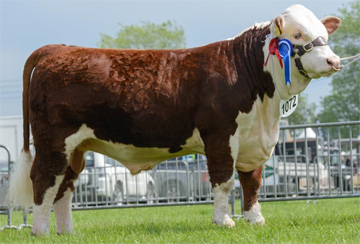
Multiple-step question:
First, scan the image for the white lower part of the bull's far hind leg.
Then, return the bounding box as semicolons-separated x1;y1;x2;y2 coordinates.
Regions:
54;188;74;234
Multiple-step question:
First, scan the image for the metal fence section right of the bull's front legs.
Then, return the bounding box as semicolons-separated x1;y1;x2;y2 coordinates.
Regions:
258;121;360;201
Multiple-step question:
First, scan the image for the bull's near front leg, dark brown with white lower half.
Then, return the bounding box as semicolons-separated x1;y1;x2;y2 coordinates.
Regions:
203;133;235;227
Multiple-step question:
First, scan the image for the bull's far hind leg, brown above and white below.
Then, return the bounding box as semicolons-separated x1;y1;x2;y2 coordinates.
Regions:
54;149;85;234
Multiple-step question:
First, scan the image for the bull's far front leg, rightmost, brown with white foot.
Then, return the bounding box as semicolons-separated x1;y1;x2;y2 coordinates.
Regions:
238;166;265;225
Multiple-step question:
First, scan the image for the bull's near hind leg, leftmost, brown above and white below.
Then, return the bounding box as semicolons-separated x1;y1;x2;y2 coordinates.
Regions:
30;150;66;236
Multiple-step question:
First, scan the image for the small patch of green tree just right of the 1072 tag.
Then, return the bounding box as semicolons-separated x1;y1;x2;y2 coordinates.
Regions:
288;93;316;125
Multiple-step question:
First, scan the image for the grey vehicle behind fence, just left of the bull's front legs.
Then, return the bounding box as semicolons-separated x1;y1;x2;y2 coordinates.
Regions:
152;154;212;202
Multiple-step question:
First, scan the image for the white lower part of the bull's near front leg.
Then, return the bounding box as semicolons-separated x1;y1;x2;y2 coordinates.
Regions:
213;177;235;227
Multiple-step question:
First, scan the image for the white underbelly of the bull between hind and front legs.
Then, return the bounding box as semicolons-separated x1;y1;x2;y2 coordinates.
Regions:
65;124;204;174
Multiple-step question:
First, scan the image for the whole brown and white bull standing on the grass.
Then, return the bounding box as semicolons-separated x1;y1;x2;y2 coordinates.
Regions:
10;5;340;235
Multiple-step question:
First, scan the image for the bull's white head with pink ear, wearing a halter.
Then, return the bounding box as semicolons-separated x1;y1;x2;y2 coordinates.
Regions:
264;5;341;99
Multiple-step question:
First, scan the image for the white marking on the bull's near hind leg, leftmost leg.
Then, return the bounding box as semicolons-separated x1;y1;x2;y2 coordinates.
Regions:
32;175;64;236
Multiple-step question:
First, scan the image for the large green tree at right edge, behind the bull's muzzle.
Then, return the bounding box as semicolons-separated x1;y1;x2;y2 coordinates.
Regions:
318;0;360;137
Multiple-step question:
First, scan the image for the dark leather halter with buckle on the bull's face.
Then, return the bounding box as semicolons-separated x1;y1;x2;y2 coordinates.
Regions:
291;36;328;79
